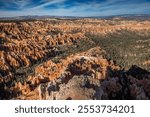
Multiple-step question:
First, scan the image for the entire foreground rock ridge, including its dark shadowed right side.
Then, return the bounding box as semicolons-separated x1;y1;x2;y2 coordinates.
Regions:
14;48;150;100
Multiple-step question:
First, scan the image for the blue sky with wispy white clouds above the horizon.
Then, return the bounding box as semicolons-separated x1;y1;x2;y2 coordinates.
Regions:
0;0;150;17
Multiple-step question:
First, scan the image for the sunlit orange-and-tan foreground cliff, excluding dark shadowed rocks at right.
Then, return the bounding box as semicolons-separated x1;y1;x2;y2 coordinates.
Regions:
13;48;117;99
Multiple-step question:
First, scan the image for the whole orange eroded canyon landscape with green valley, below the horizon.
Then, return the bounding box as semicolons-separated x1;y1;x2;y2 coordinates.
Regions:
0;18;150;100
